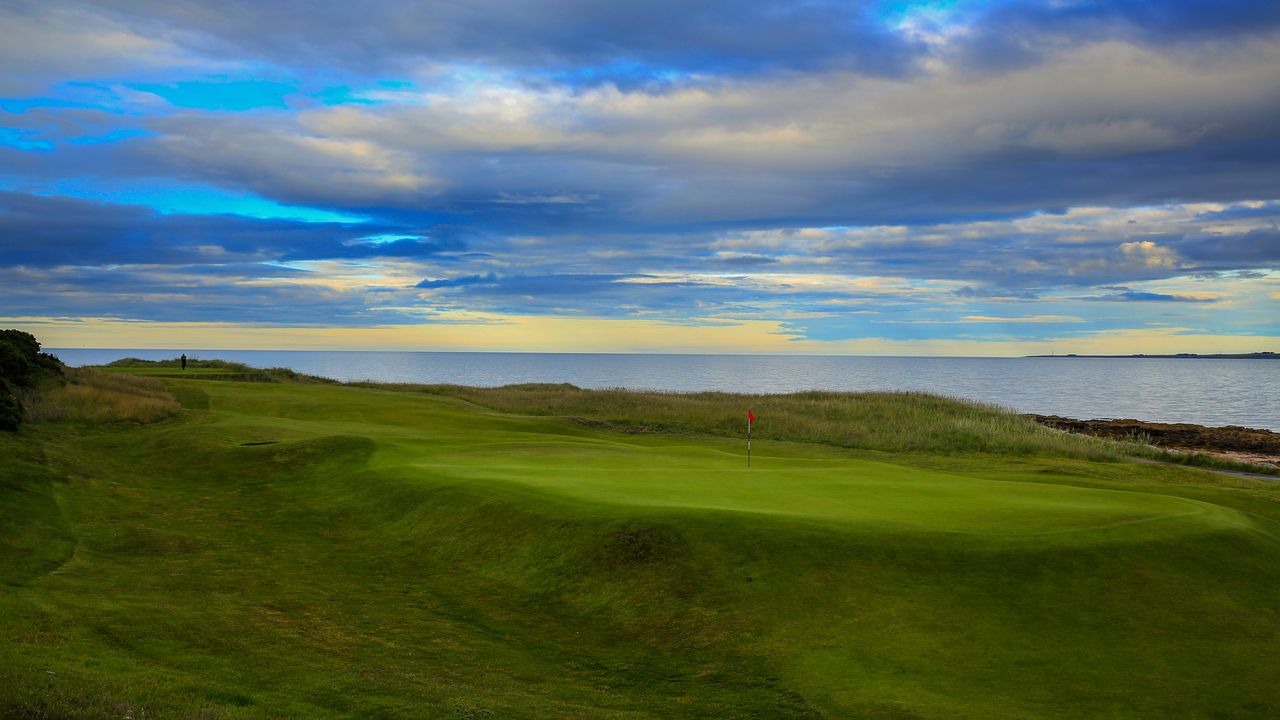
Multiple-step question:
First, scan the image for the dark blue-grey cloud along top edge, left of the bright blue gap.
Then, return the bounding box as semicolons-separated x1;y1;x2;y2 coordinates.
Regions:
65;0;919;82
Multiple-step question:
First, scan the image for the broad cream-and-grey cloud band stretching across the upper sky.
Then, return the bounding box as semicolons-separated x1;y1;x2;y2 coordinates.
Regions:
4;25;1280;233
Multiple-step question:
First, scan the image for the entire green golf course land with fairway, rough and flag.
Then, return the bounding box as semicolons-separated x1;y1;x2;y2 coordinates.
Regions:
0;361;1280;720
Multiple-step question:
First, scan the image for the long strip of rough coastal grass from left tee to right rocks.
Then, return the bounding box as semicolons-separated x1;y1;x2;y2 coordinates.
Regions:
92;357;1280;477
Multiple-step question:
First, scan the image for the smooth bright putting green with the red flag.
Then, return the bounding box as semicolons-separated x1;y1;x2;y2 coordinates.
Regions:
417;446;1247;536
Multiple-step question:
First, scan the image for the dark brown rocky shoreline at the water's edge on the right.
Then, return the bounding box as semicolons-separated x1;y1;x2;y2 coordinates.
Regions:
1027;415;1280;468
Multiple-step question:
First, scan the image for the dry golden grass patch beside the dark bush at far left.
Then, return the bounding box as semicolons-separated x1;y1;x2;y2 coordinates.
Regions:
26;368;182;423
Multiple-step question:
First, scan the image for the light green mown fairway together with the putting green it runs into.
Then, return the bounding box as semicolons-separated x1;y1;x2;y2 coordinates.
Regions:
205;383;1249;543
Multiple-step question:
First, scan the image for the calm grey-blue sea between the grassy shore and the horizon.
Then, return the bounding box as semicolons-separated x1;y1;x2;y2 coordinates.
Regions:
50;348;1280;432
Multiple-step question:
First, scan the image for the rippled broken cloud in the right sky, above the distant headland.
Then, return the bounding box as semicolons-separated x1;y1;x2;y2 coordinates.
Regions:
710;201;1280;286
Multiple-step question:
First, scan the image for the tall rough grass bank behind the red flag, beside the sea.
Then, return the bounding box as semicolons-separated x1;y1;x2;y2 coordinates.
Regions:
355;384;1137;460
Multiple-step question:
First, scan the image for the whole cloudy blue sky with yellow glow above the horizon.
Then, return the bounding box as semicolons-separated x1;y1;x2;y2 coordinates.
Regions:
0;0;1280;356
